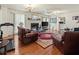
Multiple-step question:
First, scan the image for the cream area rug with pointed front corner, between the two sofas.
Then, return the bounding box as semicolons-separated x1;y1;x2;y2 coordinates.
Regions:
36;39;53;48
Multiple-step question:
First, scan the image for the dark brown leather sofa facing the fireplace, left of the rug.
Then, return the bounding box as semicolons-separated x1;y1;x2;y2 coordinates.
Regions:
18;27;38;44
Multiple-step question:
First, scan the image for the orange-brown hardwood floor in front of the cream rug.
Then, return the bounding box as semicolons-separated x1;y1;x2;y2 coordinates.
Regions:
19;43;62;55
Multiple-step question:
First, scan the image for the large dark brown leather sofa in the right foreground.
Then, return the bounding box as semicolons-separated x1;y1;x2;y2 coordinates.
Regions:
53;32;79;55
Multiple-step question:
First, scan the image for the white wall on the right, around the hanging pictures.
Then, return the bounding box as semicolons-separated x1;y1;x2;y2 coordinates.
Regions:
58;11;79;29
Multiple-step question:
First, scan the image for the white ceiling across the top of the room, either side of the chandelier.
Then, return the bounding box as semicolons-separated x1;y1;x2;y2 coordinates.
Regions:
2;4;79;15
